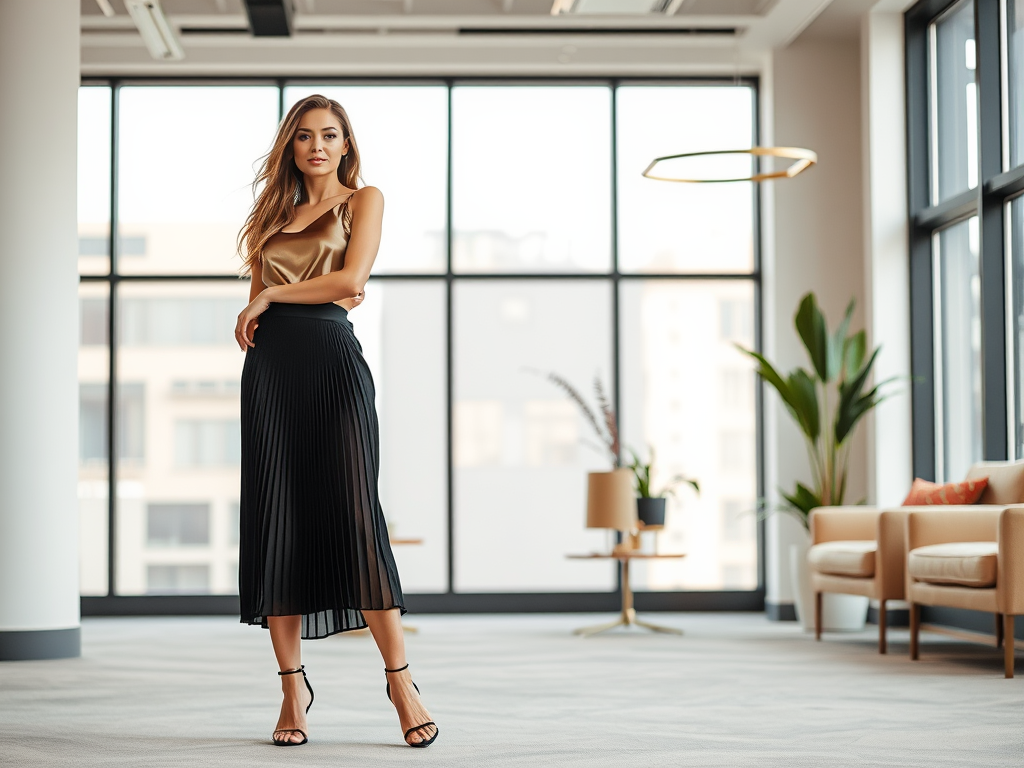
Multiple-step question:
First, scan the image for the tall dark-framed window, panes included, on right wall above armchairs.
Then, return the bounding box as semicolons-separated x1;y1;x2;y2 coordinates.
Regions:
905;0;1024;480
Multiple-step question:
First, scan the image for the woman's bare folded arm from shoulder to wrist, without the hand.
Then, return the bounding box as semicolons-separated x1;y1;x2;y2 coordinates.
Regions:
263;186;384;304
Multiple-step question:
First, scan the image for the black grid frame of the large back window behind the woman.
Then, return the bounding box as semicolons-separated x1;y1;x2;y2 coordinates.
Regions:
80;76;765;615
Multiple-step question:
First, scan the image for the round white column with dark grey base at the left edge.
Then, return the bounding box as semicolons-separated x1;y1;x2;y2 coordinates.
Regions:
0;0;80;659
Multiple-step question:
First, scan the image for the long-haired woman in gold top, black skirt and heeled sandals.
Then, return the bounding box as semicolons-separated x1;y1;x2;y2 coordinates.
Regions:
234;95;437;746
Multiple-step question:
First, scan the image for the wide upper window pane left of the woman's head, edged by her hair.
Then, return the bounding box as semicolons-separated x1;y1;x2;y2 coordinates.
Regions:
118;86;279;276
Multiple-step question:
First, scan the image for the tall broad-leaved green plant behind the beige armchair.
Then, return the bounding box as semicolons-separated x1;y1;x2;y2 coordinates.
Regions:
737;293;894;527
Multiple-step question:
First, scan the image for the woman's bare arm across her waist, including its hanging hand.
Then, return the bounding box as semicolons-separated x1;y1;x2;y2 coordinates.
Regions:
234;186;384;351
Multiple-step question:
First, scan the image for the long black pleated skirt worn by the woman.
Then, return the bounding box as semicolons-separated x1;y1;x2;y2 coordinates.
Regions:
239;303;406;639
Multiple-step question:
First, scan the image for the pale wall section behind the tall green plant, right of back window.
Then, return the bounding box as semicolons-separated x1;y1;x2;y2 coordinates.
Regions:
764;38;867;604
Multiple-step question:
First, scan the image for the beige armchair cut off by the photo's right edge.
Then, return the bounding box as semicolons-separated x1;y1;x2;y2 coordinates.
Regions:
906;512;1024;678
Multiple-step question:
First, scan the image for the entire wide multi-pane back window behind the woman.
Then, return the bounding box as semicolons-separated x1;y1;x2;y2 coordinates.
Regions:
79;80;761;609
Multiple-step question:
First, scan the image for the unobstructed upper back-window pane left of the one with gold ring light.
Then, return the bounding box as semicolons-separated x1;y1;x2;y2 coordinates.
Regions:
452;86;611;272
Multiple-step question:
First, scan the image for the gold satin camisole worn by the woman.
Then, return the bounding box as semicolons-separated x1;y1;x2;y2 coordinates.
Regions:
262;195;352;288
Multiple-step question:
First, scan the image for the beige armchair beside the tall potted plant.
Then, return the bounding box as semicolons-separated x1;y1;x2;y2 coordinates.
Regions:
807;507;906;653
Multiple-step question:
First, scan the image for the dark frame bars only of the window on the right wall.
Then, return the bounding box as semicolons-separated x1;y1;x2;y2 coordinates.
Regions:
904;0;1024;480
